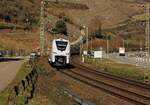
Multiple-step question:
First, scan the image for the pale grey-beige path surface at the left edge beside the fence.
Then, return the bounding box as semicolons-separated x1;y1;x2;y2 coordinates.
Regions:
0;60;25;92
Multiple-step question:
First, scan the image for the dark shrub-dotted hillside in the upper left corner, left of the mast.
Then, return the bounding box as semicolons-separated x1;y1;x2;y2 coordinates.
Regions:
0;0;40;24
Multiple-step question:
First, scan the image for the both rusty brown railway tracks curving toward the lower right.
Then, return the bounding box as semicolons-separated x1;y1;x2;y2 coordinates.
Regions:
62;63;150;105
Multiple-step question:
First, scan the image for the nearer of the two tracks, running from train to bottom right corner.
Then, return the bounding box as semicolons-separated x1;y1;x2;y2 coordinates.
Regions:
61;71;149;105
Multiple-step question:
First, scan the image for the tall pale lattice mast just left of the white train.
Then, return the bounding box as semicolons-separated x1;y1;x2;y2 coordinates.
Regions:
40;1;45;55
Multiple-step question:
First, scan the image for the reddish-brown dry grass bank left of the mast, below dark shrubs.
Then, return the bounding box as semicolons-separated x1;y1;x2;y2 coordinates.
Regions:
0;32;39;50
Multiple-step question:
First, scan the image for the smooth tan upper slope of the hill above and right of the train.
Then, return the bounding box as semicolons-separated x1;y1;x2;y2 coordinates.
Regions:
49;0;144;28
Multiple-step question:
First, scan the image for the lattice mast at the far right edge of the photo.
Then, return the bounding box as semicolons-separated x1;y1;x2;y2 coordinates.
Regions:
145;4;150;55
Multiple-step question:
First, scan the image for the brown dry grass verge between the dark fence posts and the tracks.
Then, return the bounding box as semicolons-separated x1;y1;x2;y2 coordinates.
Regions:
29;57;76;105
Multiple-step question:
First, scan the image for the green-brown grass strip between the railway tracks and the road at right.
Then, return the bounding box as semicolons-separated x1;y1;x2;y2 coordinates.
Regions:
86;58;150;83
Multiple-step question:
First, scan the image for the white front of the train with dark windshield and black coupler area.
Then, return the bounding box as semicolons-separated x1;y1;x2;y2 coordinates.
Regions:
51;39;70;66
